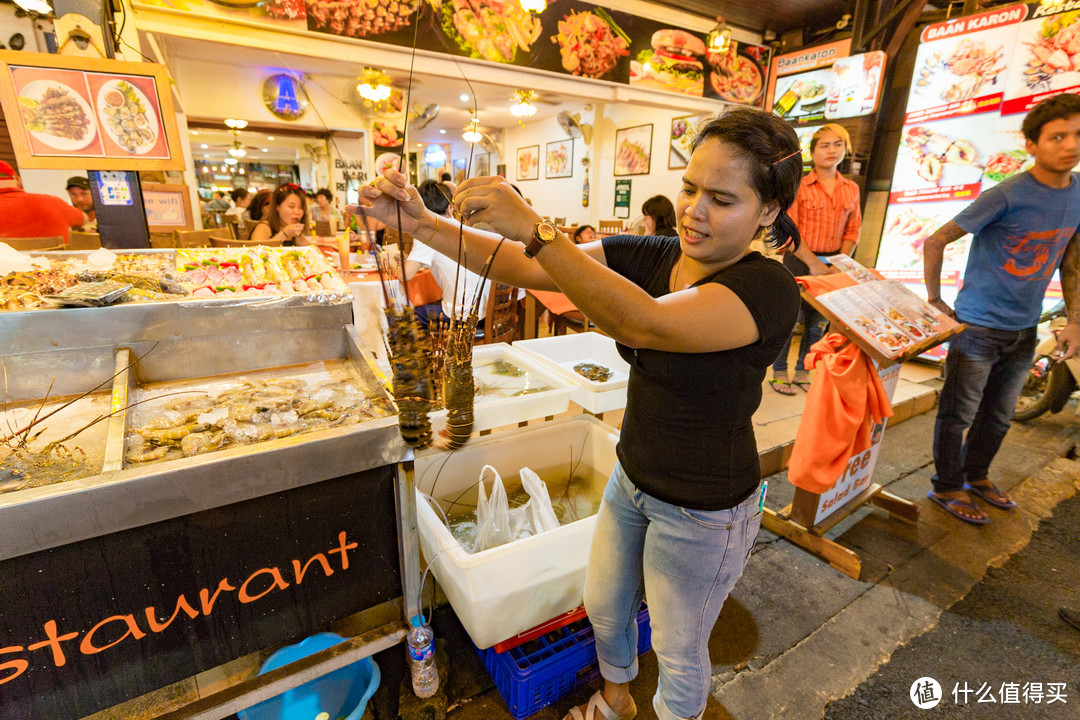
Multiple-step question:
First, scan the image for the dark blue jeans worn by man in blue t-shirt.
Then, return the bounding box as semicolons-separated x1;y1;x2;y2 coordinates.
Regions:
932;325;1038;492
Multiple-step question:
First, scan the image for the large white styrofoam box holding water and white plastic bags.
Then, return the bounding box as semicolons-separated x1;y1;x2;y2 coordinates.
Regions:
415;415;619;649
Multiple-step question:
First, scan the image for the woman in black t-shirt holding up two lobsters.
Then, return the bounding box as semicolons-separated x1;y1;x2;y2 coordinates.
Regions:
361;108;801;720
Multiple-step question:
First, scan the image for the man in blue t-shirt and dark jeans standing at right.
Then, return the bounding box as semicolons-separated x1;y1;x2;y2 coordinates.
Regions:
923;94;1080;525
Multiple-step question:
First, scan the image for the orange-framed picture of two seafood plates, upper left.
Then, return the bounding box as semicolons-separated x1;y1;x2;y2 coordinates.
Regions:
0;51;185;171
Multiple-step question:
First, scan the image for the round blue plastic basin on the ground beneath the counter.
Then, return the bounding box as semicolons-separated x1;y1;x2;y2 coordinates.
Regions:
238;633;379;720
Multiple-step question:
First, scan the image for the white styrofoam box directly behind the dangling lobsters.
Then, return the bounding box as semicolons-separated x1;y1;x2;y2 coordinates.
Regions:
431;342;572;435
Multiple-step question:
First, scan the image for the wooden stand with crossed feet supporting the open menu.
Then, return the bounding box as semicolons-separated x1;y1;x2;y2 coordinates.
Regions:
761;290;968;580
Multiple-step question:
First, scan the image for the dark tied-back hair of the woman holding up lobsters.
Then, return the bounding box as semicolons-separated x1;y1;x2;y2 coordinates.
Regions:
691;108;802;249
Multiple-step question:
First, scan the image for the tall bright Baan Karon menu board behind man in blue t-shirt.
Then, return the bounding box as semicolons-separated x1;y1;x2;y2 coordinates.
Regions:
877;3;1080;304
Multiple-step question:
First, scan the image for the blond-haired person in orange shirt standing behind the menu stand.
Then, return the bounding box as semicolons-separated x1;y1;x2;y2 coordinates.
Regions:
769;123;863;395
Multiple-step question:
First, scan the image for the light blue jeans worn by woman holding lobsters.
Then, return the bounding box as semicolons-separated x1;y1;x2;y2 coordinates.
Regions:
585;464;761;720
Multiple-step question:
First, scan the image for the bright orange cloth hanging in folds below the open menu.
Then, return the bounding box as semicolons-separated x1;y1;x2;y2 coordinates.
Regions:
787;332;892;494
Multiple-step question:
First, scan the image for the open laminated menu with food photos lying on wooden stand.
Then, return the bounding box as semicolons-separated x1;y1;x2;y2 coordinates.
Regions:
815;255;957;357
